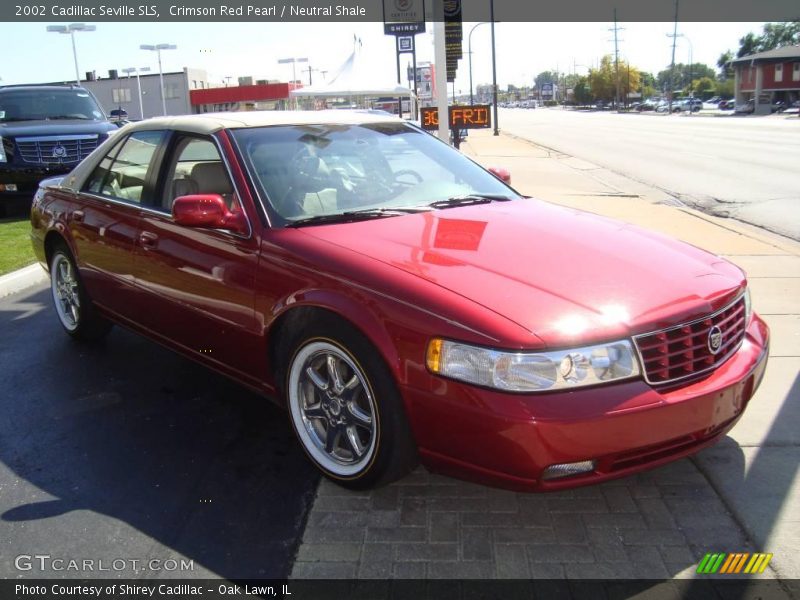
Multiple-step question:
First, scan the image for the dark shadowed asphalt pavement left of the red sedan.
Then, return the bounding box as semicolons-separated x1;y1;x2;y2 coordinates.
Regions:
0;284;318;578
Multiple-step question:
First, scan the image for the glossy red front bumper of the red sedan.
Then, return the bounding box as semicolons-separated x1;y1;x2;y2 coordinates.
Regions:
402;314;769;491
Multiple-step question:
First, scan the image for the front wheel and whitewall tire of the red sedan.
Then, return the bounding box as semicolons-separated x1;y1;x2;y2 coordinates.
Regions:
278;316;417;489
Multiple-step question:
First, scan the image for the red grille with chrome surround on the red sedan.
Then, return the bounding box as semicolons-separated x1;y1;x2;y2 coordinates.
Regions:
633;296;745;385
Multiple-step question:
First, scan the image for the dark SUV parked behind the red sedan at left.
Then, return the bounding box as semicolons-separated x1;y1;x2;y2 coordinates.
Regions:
0;85;117;214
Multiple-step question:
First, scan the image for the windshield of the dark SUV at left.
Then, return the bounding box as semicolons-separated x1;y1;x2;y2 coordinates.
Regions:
0;89;105;122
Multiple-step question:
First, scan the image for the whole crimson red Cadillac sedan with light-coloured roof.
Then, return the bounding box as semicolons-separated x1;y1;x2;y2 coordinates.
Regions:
31;111;768;490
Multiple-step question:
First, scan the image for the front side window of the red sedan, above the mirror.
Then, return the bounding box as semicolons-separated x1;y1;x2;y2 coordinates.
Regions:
161;136;239;212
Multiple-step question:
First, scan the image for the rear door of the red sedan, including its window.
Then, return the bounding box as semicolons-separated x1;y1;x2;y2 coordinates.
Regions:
69;131;166;319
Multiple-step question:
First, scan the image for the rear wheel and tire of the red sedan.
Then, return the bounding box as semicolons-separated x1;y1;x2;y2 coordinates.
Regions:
50;245;111;342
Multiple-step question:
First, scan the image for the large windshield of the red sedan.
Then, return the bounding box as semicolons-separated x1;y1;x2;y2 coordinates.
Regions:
232;122;519;225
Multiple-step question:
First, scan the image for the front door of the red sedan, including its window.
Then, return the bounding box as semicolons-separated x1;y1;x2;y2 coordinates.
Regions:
137;132;265;379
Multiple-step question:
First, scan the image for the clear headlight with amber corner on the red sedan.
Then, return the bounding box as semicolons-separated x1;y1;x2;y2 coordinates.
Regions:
426;338;639;392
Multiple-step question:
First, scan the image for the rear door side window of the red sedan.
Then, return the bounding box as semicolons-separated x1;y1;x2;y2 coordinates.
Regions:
86;131;164;204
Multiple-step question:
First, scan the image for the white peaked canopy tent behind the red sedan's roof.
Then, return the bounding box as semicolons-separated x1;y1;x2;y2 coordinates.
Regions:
289;49;414;113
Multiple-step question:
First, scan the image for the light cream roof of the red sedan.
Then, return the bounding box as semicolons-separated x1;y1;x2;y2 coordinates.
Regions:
125;110;403;134
